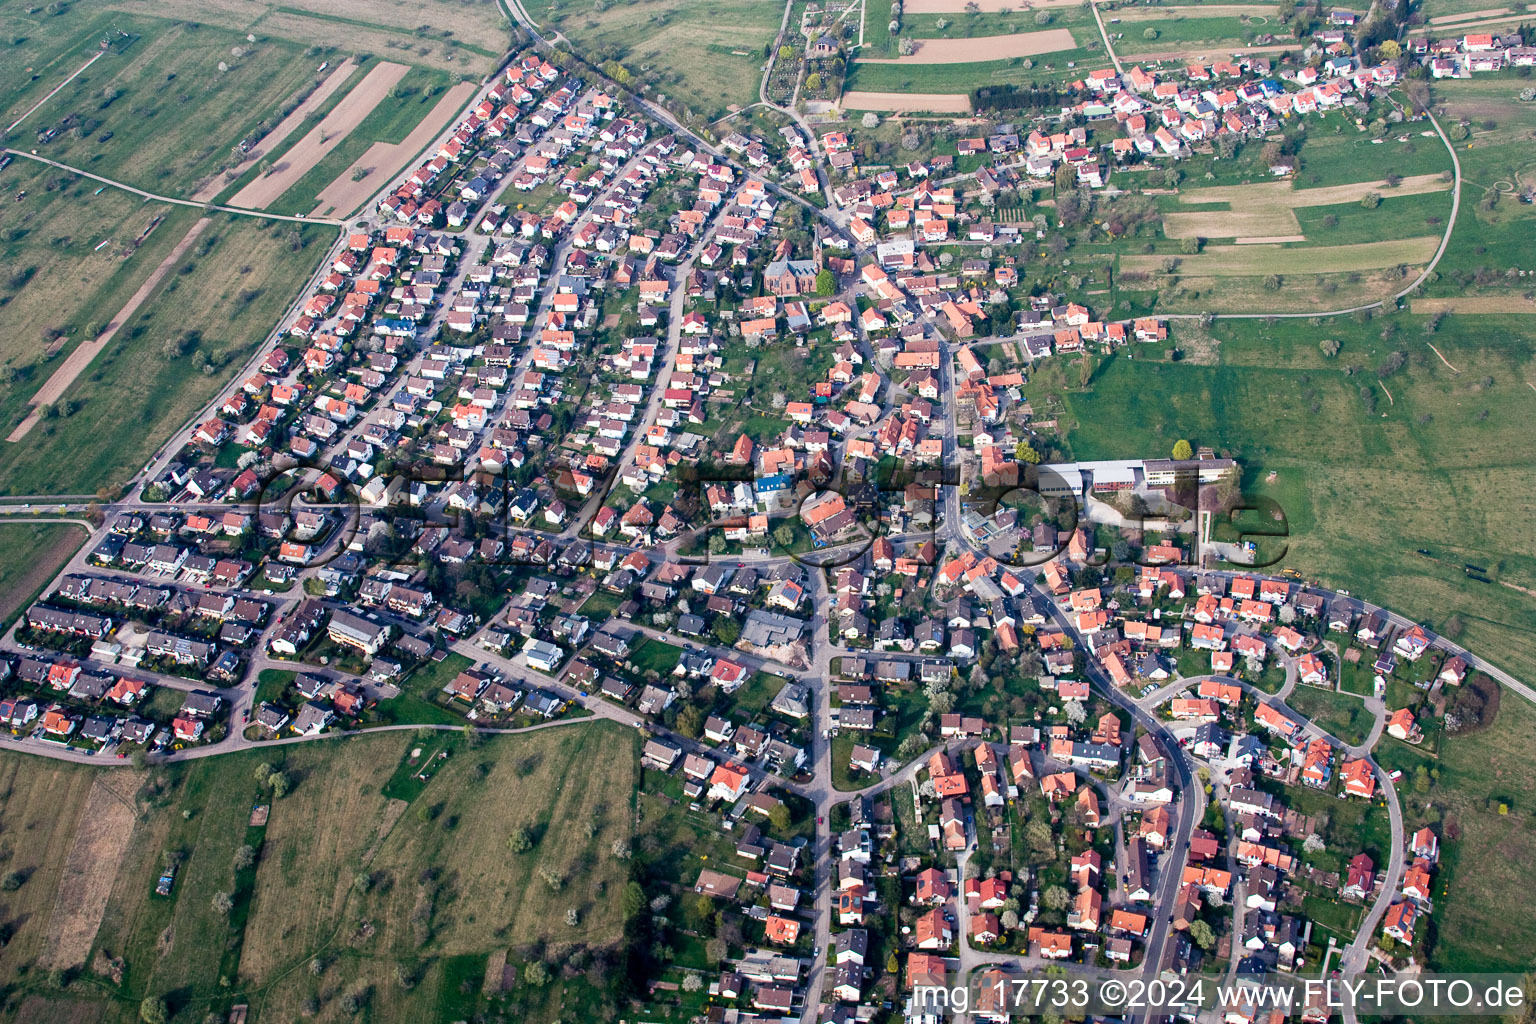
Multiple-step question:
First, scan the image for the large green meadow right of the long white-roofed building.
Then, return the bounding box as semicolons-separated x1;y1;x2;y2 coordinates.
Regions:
1031;313;1536;679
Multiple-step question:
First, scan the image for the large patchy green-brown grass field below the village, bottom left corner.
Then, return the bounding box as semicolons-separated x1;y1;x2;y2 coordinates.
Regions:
0;725;637;1022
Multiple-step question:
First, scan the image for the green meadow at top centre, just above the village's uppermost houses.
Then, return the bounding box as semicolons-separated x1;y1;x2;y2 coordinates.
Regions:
524;0;783;117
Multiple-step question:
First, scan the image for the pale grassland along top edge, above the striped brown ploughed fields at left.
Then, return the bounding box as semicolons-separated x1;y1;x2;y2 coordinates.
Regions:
111;0;511;77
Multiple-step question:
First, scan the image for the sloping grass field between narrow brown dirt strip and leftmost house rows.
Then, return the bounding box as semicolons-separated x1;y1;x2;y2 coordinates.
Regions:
0;215;333;494
